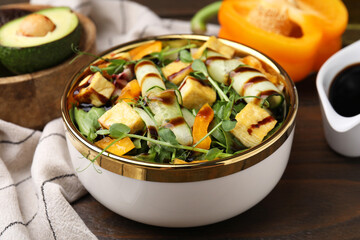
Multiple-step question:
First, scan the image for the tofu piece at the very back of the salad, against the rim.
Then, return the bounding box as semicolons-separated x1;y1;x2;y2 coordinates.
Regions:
192;36;235;59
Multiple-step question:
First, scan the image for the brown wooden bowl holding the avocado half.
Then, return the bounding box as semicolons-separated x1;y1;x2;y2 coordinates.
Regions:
0;4;96;130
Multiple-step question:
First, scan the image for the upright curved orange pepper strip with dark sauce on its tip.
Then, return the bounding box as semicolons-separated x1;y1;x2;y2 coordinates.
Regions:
193;103;214;149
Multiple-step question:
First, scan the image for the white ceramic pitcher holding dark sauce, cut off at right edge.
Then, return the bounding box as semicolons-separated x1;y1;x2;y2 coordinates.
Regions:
316;41;360;157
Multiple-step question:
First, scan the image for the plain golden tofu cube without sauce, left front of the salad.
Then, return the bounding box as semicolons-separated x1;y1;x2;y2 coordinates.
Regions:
98;101;145;133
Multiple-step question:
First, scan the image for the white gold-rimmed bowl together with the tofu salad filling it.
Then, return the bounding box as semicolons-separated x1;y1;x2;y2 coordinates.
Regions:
61;35;298;227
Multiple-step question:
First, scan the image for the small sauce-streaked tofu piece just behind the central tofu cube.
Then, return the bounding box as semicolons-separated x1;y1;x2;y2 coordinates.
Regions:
161;60;192;85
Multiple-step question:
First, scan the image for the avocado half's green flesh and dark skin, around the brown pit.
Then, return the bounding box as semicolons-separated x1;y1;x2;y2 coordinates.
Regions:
0;7;81;74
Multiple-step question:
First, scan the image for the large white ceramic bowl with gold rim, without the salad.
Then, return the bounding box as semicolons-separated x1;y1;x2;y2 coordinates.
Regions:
62;35;298;227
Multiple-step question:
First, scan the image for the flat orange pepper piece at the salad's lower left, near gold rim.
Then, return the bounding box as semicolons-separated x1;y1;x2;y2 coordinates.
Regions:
95;137;135;156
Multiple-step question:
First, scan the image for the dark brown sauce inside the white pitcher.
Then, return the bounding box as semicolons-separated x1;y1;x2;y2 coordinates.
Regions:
329;63;360;117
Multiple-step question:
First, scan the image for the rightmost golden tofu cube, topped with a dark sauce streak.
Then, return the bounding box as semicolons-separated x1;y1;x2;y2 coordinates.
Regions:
230;102;277;147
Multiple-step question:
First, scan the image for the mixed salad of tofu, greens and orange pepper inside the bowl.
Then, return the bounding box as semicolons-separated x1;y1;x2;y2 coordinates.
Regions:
69;34;287;164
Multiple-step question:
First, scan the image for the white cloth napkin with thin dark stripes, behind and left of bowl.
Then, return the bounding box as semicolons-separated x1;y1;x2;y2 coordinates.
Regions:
0;0;218;240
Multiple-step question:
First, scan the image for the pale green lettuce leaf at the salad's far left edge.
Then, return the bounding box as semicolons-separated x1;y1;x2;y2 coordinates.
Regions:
74;107;105;142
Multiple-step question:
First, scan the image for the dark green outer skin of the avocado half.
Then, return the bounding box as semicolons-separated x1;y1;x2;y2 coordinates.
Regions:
0;24;82;74
